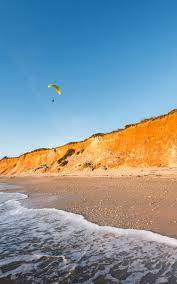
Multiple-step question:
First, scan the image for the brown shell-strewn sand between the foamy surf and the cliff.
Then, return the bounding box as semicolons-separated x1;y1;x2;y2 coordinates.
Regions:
0;171;177;238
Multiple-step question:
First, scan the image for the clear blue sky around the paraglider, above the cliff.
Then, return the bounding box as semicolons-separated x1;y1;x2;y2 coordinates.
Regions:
0;0;177;156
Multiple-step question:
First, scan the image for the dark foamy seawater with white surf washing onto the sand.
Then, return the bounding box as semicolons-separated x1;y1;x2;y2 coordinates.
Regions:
0;184;177;284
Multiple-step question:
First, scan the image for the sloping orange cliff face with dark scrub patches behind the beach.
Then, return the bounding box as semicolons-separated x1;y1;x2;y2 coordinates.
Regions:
0;110;177;175
